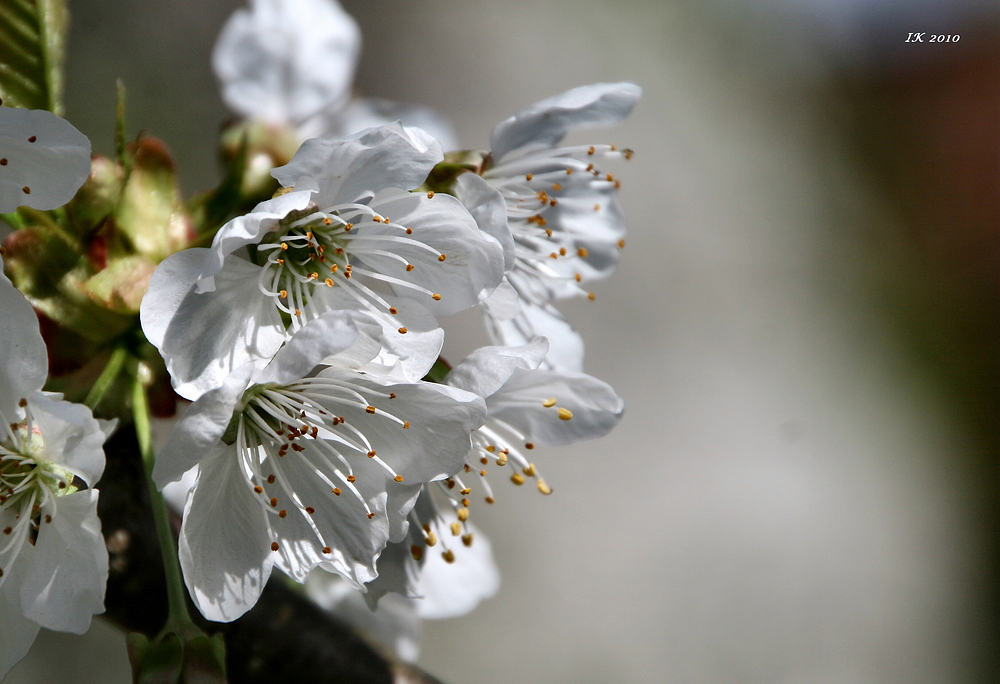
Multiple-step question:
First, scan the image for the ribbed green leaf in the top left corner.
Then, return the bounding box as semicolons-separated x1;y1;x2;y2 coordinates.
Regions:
0;0;69;116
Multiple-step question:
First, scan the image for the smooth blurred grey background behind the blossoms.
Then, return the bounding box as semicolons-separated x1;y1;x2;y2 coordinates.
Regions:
6;0;1000;684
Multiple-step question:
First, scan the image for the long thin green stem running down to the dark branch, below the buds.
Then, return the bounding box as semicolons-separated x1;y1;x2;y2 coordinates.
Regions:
132;373;201;640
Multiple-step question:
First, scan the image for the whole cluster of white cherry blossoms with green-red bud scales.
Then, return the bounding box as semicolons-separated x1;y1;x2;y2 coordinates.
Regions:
0;0;641;676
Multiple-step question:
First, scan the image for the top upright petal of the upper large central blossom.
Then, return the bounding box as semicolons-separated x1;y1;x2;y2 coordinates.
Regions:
271;123;444;208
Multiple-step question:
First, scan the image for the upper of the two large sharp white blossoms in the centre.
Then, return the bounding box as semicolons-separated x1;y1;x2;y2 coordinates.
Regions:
140;124;506;399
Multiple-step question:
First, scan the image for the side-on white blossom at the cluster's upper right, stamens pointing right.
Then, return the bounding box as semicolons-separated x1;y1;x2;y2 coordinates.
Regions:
470;83;642;372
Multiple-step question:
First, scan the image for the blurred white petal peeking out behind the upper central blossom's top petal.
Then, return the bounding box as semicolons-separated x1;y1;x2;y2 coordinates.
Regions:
320;97;459;150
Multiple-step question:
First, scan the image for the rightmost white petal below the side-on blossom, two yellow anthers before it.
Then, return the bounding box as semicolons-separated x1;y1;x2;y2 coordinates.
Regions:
486;369;625;446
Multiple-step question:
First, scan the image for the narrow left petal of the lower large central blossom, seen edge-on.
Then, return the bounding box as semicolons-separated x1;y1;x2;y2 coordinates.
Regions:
153;363;253;489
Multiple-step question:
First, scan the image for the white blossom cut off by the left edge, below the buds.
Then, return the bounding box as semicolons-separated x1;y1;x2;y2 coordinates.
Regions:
0;261;108;677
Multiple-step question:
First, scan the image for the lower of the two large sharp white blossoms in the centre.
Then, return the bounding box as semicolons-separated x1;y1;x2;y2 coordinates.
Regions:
153;312;485;621
